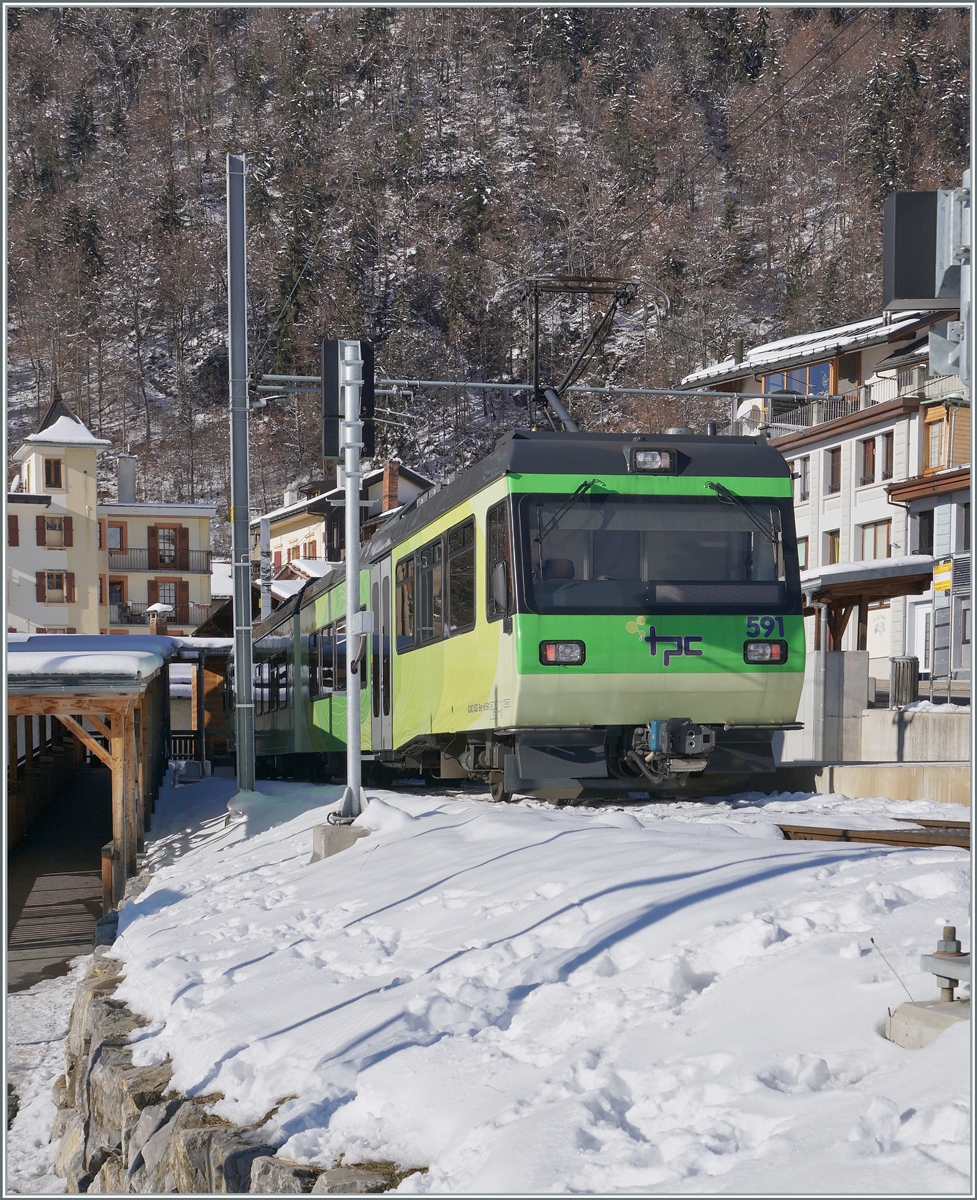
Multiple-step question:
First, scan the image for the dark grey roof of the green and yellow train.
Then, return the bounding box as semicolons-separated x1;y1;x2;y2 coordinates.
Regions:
254;430;789;637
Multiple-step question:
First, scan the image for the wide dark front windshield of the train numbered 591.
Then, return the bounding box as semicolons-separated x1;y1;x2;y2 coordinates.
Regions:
517;493;799;613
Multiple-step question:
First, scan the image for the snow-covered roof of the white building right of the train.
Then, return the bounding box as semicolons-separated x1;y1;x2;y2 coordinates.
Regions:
679;312;946;388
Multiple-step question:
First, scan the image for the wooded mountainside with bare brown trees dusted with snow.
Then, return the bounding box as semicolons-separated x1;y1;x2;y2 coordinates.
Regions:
7;6;970;537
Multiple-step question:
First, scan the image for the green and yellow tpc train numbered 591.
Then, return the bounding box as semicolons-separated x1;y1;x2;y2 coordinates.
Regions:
254;431;804;800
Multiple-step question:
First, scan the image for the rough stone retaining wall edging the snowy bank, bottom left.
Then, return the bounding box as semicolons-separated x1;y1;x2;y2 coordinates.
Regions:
52;944;417;1195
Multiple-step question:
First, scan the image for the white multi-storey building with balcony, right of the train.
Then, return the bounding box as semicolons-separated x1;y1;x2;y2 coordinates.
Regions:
682;304;971;680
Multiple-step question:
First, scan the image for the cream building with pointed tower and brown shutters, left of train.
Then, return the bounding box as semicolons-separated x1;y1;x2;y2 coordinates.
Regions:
6;400;217;634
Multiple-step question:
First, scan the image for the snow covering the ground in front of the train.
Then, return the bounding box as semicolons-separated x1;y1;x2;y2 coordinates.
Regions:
3;779;971;1195
